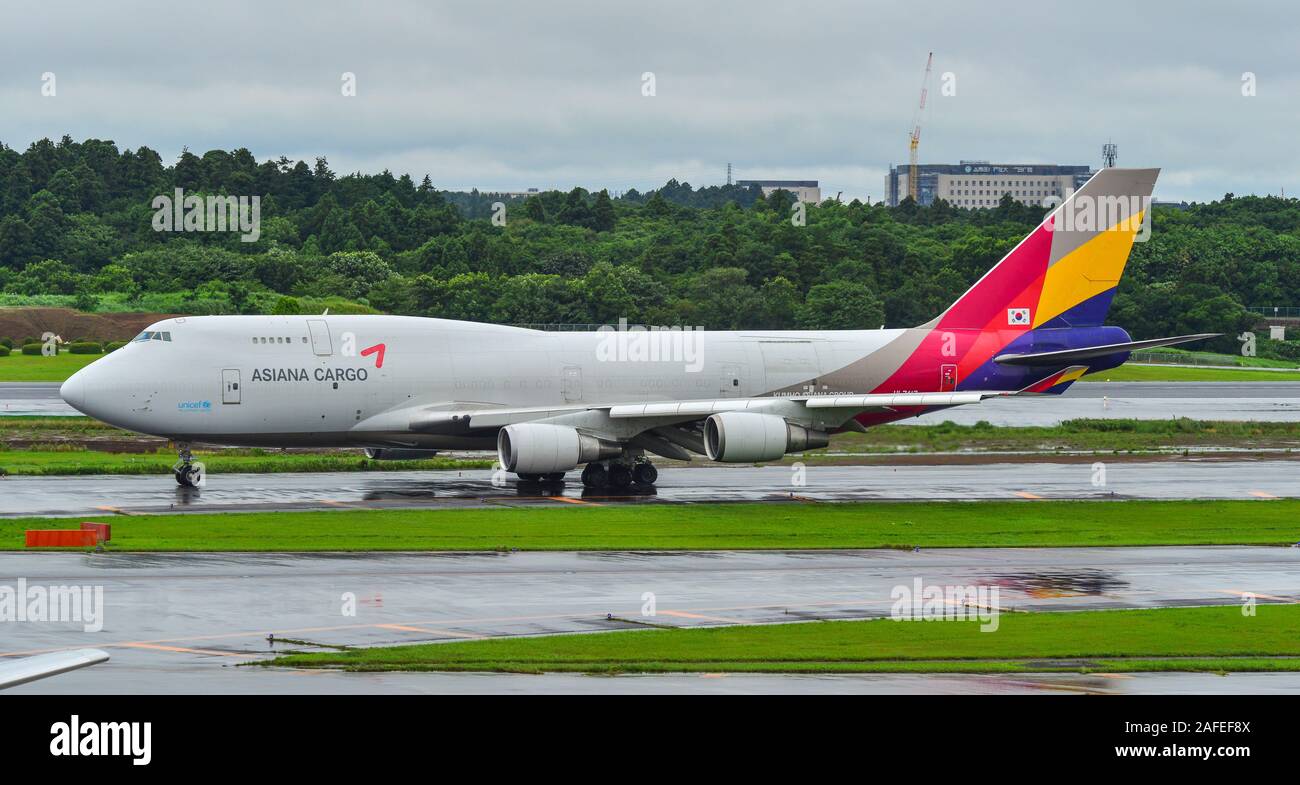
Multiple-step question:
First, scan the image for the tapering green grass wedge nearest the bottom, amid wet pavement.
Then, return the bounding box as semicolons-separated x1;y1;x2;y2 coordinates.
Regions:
263;604;1300;673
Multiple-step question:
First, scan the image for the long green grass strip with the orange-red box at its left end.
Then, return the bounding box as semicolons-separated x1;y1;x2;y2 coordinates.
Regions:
0;489;1300;551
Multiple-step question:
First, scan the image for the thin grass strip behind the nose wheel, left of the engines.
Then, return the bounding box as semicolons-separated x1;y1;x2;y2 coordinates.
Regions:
0;450;495;477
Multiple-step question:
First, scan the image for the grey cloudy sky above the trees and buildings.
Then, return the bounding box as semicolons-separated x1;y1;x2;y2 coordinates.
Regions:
0;0;1300;199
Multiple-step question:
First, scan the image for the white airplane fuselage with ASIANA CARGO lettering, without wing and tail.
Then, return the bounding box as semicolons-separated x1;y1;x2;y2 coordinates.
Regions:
62;316;902;448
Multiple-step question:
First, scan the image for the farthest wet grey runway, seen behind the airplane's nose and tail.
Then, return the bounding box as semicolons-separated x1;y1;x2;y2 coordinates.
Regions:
0;374;1300;425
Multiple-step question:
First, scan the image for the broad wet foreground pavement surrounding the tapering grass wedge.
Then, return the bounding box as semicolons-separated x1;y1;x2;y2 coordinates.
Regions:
0;547;1300;694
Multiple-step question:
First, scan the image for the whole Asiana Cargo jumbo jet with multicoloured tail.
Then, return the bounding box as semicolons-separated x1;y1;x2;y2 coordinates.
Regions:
60;168;1216;489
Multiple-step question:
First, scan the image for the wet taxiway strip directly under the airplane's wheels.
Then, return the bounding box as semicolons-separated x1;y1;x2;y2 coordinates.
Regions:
0;456;1300;517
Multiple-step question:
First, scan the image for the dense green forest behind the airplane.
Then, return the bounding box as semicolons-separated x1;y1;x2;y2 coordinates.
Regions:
0;136;1300;357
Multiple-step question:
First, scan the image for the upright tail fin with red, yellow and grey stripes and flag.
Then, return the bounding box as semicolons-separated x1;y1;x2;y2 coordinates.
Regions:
928;169;1160;330
